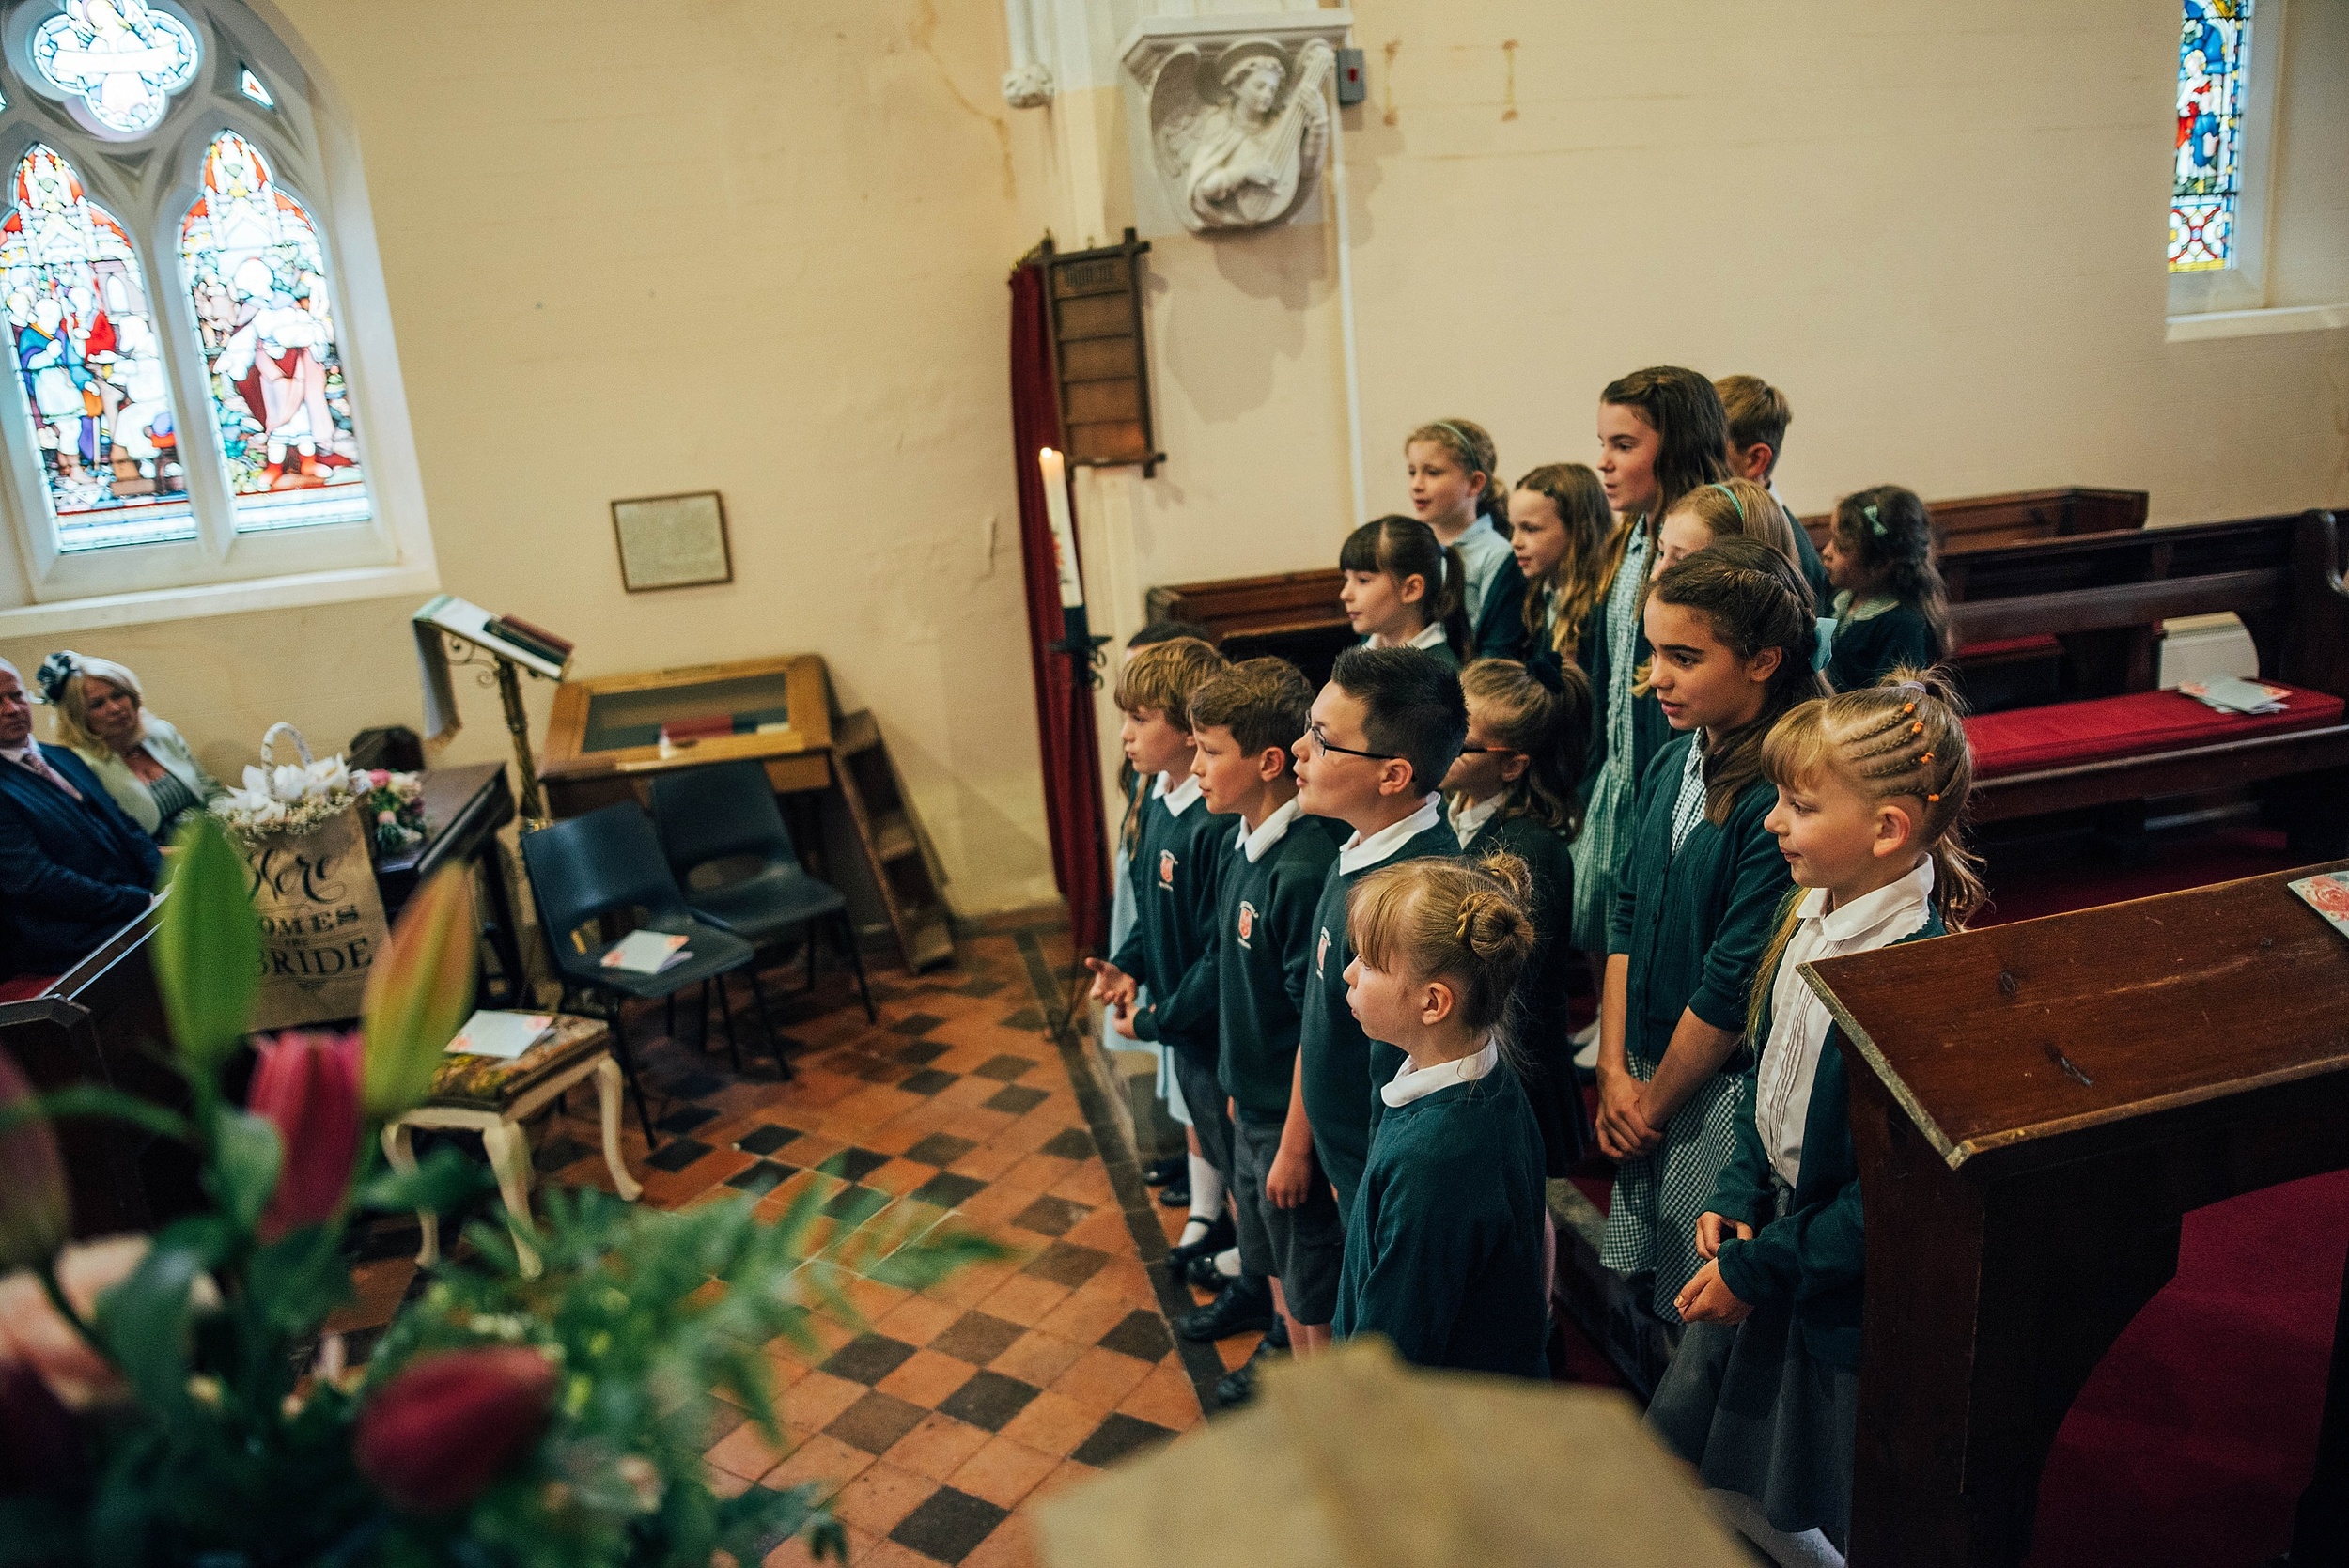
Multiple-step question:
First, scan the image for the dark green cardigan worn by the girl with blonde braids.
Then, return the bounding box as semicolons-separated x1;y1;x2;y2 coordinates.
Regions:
1705;910;1950;1371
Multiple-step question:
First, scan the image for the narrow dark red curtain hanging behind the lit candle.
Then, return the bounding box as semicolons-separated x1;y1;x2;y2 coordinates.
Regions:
1013;265;1109;953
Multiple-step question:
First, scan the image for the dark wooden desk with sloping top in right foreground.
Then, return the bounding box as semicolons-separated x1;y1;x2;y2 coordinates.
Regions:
1807;862;2349;1568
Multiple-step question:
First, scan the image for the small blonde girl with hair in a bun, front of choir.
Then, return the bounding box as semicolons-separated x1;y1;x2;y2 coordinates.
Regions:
1332;854;1548;1378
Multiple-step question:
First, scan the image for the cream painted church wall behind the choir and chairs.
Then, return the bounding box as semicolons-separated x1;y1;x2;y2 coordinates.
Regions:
0;0;2349;910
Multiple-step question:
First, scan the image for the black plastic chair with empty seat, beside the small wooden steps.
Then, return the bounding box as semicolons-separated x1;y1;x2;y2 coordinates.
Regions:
653;761;879;1042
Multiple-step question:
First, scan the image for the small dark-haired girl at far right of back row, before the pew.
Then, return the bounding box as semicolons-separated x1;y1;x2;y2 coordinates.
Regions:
1821;484;1950;692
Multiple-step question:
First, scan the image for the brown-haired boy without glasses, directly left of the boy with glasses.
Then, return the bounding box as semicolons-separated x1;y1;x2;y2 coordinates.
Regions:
1184;660;1346;1408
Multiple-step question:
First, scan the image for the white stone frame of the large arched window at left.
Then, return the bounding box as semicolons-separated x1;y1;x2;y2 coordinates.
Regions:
0;0;440;636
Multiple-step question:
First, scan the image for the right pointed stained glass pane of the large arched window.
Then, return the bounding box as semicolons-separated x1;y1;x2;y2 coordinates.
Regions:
179;132;369;533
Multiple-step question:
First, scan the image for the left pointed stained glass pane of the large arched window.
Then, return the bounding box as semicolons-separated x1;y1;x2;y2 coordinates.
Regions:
0;143;195;550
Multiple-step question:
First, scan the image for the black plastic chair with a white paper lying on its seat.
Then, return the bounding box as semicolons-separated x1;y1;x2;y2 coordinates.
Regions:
521;800;789;1143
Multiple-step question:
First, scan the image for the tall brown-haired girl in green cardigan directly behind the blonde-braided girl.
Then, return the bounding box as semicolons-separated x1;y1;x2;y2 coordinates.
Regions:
1577;537;1828;1327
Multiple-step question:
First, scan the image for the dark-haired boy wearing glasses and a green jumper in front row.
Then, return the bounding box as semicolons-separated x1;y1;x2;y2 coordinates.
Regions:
1297;648;1469;1214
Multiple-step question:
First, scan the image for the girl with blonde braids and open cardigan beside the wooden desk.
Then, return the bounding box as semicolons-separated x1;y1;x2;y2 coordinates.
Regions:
1649;669;1983;1563
